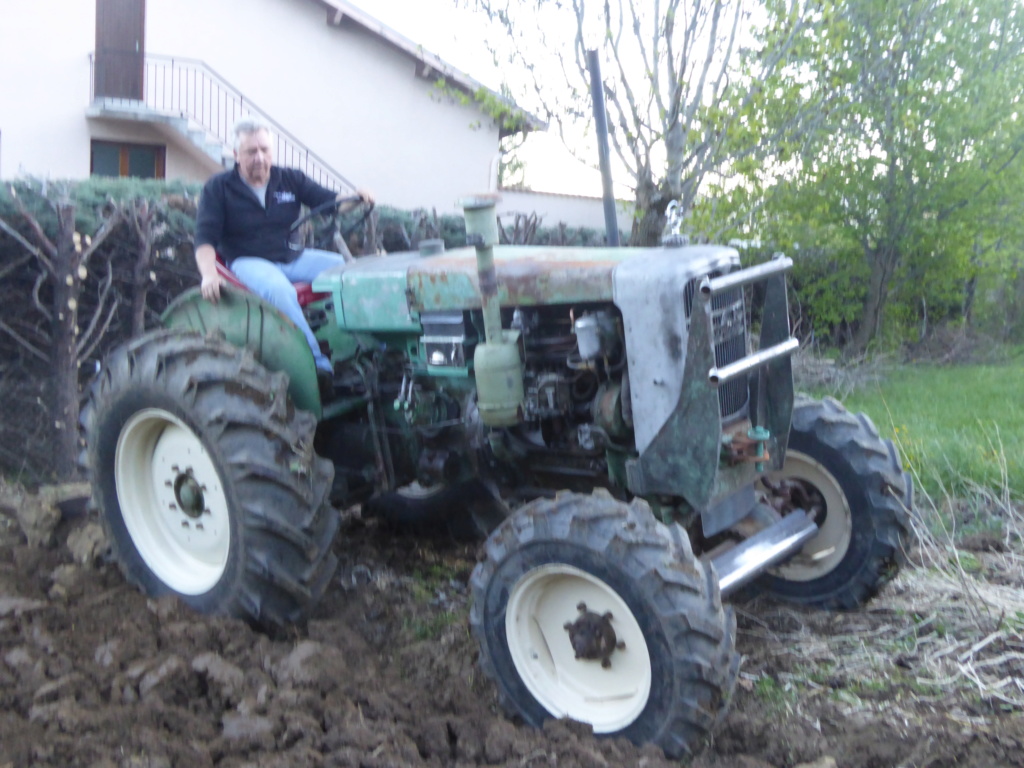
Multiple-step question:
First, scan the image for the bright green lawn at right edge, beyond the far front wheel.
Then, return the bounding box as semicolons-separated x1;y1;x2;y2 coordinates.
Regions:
815;358;1024;499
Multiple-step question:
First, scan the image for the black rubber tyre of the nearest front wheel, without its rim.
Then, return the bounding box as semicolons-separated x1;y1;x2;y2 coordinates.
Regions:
470;493;740;758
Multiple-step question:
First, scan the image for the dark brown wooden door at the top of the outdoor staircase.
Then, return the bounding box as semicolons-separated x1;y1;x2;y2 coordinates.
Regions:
94;0;145;100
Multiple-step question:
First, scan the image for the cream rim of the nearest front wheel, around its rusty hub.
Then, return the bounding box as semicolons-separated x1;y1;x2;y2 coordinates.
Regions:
505;563;651;733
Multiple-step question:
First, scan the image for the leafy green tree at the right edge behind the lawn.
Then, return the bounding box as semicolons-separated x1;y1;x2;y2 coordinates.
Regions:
765;0;1024;349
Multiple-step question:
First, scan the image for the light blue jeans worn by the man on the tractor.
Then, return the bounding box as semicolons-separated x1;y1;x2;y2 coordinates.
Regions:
231;248;345;371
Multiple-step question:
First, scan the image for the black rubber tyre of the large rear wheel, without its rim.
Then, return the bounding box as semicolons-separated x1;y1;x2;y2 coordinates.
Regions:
80;329;339;629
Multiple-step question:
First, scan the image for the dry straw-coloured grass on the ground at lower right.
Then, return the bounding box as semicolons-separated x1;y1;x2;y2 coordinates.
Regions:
740;462;1024;726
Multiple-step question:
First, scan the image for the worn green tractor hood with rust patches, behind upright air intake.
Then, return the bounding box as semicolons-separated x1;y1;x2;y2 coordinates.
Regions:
313;246;738;331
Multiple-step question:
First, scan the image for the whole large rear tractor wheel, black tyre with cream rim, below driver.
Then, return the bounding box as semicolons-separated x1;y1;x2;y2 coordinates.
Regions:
82;331;339;628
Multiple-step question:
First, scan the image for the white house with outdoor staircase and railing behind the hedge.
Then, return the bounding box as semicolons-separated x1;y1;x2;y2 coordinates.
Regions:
0;0;541;213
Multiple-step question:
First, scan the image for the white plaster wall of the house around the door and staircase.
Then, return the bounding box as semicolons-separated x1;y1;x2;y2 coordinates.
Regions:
0;0;498;213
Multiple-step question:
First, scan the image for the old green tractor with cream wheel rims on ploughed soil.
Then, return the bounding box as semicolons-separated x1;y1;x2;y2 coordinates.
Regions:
83;196;911;756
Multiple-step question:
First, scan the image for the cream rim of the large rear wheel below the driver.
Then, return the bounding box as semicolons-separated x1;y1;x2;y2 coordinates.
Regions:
115;409;231;595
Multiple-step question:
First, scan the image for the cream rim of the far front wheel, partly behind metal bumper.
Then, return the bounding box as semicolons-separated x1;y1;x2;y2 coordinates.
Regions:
769;450;853;582
